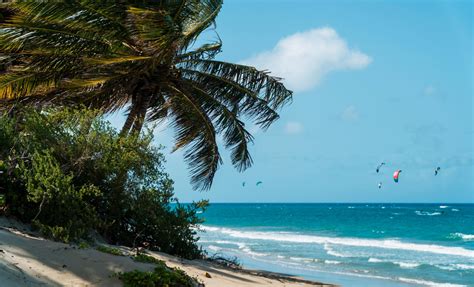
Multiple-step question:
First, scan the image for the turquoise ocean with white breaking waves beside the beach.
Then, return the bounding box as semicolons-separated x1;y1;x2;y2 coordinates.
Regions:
199;204;474;287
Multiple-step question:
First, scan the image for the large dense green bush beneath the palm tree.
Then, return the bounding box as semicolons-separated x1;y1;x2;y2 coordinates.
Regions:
0;109;207;258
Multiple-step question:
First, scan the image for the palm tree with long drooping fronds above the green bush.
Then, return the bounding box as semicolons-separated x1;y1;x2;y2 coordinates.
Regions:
0;0;292;189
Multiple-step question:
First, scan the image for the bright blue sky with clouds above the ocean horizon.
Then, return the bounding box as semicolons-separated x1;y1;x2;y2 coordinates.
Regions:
113;0;474;203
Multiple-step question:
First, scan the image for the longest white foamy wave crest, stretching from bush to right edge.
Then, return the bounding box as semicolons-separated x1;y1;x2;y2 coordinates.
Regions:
201;226;474;258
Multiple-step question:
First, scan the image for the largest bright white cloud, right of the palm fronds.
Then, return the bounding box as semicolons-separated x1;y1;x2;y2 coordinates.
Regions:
242;27;372;91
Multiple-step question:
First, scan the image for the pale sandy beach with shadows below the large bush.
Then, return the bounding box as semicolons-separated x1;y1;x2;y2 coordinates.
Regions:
0;218;333;287
